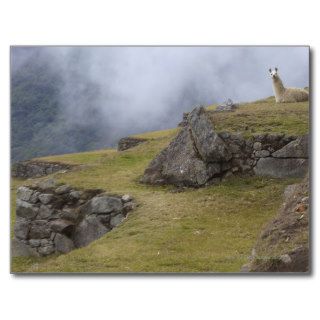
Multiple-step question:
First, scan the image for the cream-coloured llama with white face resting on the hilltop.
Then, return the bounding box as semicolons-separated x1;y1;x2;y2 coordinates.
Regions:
269;68;309;103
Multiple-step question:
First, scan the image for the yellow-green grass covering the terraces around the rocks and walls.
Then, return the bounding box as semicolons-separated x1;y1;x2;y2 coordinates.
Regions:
12;99;308;272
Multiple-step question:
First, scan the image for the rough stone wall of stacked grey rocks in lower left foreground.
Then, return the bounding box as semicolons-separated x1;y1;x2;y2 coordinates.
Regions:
12;180;135;256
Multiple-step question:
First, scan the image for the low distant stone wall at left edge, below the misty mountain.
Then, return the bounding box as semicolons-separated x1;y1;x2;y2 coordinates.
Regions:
11;160;73;179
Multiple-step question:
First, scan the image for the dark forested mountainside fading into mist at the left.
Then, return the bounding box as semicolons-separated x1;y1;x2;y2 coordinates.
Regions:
11;54;109;162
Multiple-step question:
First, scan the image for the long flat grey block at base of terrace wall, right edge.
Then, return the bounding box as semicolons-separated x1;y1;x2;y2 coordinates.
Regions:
254;157;309;178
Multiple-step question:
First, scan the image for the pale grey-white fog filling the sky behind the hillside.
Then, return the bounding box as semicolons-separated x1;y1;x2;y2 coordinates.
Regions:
11;47;309;150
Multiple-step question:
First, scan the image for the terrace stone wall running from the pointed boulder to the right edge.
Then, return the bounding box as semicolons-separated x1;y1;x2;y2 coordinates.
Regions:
218;133;308;178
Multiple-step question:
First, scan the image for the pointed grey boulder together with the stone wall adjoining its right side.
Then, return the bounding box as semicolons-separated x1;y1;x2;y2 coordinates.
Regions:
141;107;308;187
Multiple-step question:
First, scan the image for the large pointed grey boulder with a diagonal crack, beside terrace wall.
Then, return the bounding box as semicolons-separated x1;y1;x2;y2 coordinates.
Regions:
141;107;226;187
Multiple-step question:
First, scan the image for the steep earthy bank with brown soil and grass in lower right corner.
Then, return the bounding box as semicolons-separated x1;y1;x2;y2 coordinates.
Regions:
243;178;309;272
